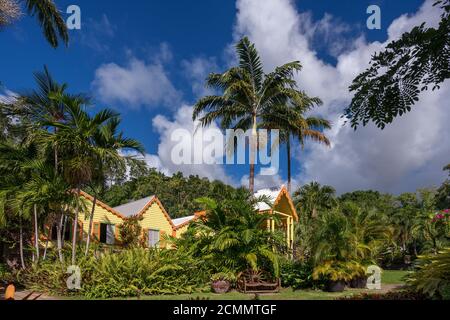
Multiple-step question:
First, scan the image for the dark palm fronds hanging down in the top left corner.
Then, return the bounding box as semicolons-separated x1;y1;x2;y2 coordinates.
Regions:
0;0;69;48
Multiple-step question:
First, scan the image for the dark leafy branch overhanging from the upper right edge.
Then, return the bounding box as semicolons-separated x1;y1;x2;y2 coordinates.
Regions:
344;0;450;129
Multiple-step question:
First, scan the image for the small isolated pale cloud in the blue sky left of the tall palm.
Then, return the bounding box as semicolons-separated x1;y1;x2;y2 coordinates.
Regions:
92;53;180;108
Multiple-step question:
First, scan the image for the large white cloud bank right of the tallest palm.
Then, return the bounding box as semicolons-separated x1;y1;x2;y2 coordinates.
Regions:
234;0;450;192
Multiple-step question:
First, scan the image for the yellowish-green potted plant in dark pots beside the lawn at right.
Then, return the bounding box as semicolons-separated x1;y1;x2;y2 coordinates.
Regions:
313;261;351;292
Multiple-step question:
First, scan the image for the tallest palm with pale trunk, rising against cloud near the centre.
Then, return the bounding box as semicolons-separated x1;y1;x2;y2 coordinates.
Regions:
192;37;301;192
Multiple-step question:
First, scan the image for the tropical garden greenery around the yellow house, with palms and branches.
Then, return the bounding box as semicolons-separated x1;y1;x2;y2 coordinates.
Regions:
0;1;450;299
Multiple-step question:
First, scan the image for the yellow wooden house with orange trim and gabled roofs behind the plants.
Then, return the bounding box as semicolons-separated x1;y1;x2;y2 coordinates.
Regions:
45;186;298;248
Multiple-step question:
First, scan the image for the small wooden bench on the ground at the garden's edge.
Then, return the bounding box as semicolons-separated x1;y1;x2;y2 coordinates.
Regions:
237;270;281;293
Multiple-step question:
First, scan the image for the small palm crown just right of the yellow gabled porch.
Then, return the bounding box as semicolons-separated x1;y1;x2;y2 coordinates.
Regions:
294;181;336;218
